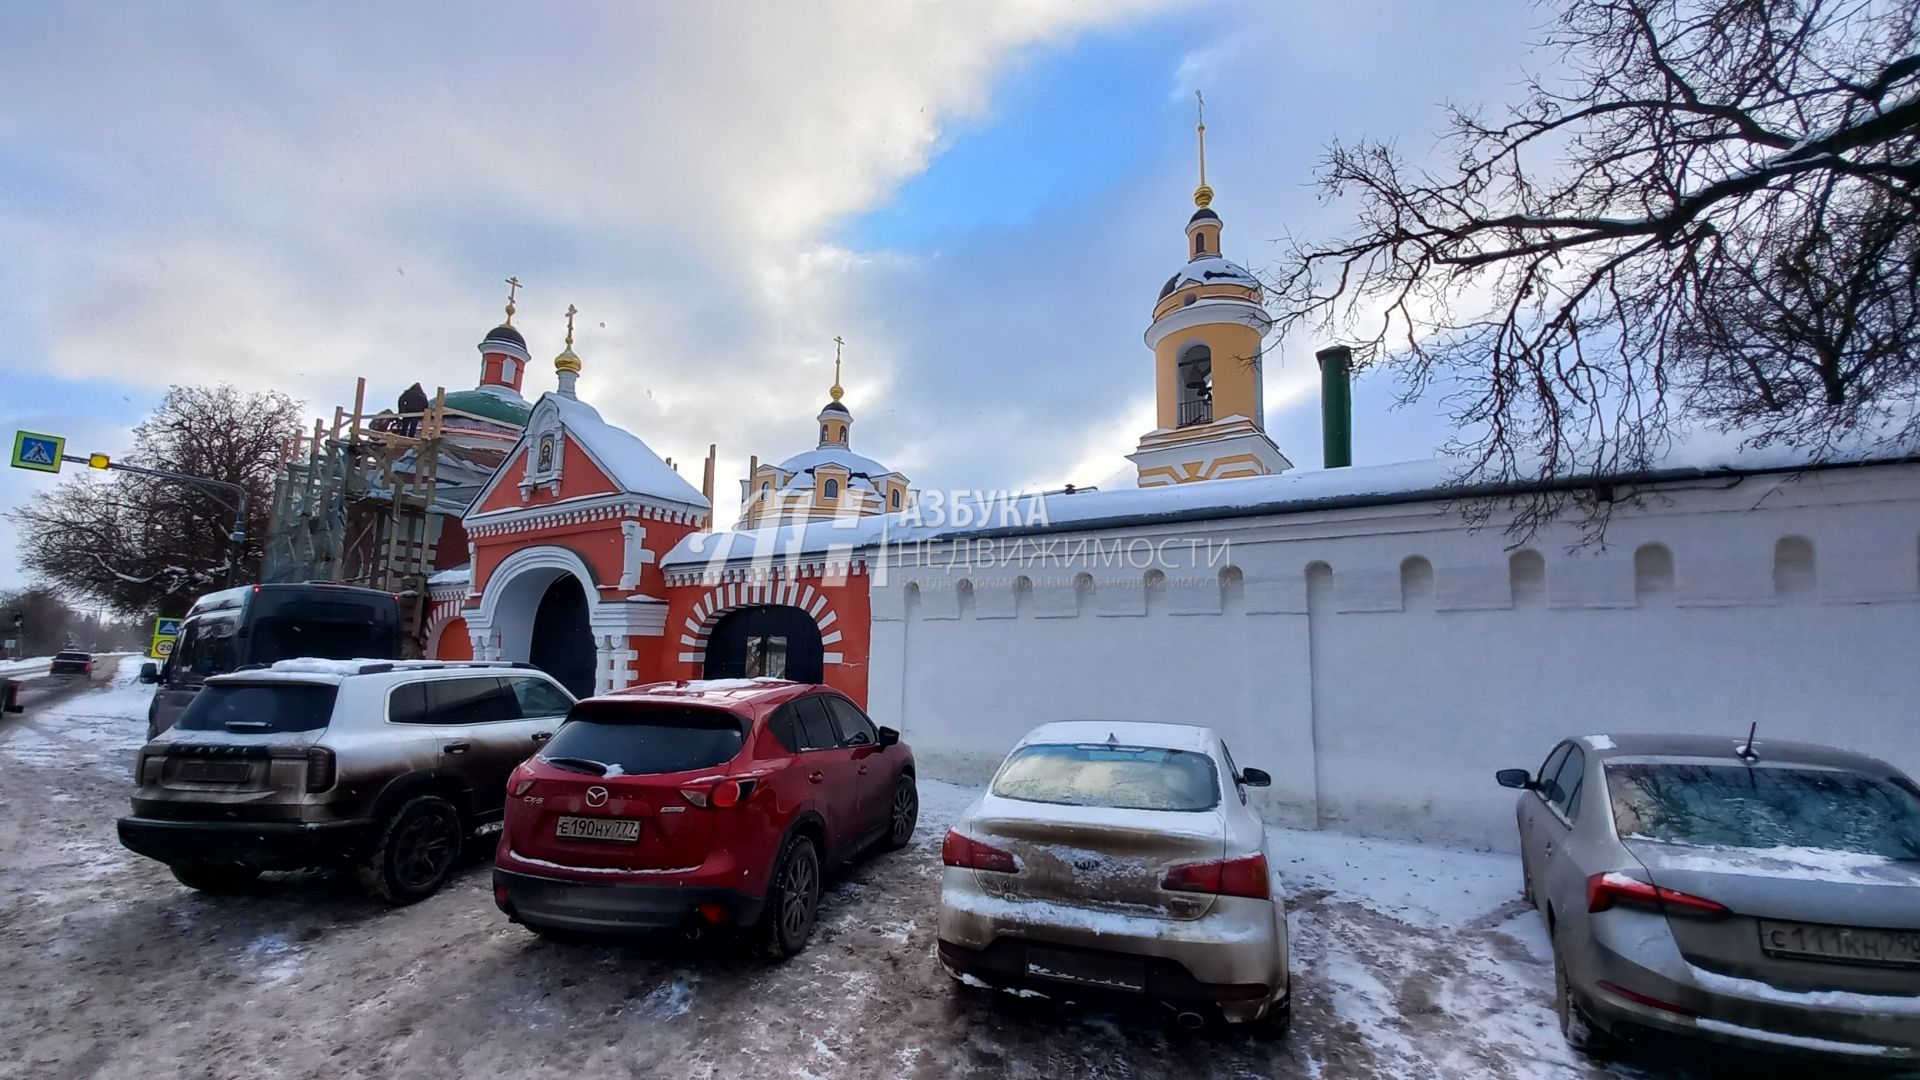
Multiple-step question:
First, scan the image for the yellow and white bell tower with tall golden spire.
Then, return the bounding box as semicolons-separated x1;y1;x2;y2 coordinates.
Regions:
1127;94;1292;488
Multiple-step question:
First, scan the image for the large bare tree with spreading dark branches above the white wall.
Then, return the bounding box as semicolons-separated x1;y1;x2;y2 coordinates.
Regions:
1269;0;1920;528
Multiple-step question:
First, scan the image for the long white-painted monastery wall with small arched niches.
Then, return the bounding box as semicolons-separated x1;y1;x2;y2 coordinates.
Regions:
870;457;1920;849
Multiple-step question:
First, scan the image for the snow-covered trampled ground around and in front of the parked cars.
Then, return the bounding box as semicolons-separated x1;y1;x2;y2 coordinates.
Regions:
0;659;1827;1080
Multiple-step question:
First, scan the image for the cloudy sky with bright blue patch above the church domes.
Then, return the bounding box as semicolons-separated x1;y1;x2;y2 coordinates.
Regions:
0;0;1546;588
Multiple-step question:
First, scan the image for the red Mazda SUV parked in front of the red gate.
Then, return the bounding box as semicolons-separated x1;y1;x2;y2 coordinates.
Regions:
493;678;920;957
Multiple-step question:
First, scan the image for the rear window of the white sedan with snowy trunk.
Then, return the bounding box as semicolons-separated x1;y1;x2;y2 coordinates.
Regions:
993;744;1219;811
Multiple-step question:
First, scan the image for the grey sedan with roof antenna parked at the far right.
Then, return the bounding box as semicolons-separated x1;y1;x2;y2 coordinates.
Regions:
1498;734;1920;1065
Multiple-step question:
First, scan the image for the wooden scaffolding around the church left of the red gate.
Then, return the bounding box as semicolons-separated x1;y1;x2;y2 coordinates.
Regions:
261;379;468;650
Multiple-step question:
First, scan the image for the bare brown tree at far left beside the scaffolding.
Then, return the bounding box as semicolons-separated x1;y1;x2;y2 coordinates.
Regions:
12;384;300;615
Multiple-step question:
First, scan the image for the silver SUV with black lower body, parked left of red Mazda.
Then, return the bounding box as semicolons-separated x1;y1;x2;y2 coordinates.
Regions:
119;659;574;903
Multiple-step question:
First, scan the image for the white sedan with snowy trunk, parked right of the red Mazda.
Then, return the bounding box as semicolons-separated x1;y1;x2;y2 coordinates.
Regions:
939;721;1292;1028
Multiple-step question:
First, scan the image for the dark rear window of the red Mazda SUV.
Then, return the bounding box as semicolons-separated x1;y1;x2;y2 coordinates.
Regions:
540;701;747;776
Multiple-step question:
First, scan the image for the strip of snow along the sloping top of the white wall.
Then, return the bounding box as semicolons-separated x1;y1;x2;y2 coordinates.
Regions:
660;440;1907;569
